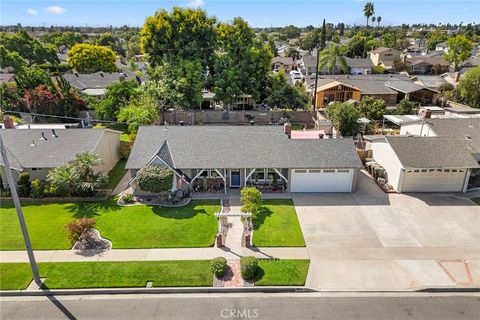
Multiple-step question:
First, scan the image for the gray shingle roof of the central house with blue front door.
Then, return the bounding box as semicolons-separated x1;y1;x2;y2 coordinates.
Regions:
126;126;361;169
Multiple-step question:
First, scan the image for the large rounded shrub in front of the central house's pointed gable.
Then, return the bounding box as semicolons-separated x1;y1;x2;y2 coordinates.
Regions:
137;165;173;193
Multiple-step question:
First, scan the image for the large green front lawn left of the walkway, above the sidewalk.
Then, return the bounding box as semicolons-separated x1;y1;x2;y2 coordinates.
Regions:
0;199;220;250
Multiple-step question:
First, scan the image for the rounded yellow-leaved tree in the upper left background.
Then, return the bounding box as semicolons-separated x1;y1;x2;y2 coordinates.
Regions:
68;43;117;73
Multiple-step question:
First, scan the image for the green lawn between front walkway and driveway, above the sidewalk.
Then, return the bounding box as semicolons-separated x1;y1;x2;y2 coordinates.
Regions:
253;199;305;247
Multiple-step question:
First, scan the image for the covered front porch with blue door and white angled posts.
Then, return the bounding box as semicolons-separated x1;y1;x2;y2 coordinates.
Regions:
186;168;288;193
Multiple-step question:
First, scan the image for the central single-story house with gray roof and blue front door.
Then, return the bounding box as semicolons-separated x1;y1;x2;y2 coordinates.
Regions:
126;126;362;192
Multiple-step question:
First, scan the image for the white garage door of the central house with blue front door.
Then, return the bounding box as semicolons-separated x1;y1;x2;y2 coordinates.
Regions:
290;169;353;192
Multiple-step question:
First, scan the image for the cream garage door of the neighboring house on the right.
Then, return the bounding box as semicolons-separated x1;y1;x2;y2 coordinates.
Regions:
402;169;466;192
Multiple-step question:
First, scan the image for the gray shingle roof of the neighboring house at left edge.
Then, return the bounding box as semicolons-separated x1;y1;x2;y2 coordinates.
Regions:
0;129;105;169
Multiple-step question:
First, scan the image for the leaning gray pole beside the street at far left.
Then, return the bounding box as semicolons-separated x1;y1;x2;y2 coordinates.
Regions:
0;134;42;287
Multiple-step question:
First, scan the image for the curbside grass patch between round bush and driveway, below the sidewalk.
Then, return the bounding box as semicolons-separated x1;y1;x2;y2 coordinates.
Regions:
255;260;310;286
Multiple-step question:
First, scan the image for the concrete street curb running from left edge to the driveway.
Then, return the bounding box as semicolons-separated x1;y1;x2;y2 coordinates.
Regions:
0;287;318;297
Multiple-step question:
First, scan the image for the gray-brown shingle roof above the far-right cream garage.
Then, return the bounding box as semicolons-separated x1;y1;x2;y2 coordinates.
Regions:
385;136;480;168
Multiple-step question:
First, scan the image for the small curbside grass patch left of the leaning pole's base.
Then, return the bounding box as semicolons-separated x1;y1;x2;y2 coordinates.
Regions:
0;263;33;290
